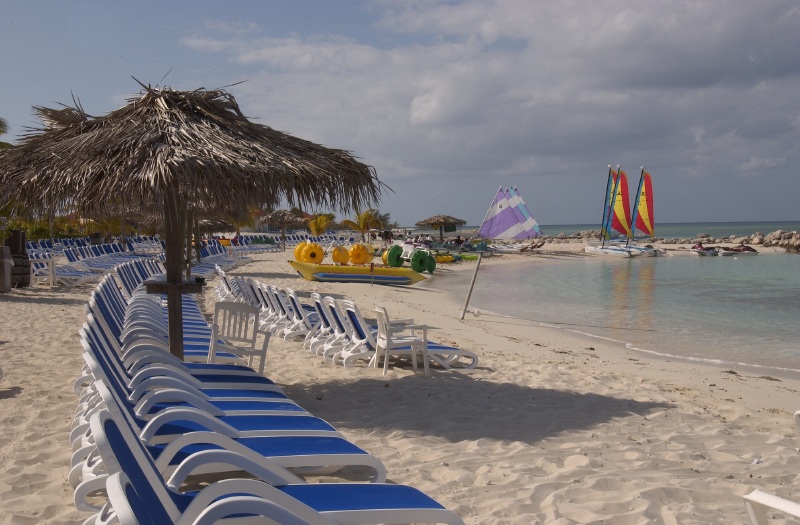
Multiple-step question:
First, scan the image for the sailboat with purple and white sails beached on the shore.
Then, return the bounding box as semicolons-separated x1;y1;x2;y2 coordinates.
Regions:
478;186;542;253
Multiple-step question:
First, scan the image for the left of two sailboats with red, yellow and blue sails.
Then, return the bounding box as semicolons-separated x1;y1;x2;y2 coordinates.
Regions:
584;166;639;257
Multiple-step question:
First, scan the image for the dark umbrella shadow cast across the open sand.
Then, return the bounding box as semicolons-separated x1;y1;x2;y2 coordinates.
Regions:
278;372;673;443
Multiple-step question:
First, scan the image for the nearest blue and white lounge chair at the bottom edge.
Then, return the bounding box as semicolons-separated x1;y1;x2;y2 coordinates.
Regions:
79;411;463;525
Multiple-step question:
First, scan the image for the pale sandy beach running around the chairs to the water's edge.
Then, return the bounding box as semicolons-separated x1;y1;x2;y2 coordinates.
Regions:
0;243;800;525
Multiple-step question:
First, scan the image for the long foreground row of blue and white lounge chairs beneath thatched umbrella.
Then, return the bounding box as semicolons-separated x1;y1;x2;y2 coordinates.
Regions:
69;261;463;525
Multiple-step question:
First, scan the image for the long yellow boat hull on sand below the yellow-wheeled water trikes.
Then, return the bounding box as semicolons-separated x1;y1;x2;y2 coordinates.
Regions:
289;261;425;285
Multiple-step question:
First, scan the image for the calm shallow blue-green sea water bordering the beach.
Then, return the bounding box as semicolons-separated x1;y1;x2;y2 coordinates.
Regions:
432;223;800;374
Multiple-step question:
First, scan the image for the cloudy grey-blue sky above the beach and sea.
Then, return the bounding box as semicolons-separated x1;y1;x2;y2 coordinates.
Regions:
0;0;800;227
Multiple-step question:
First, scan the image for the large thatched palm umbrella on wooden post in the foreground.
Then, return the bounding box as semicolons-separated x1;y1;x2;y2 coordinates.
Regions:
0;84;382;357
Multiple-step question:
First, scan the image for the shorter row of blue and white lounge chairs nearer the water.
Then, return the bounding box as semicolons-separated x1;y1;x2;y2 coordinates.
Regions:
216;270;478;375
